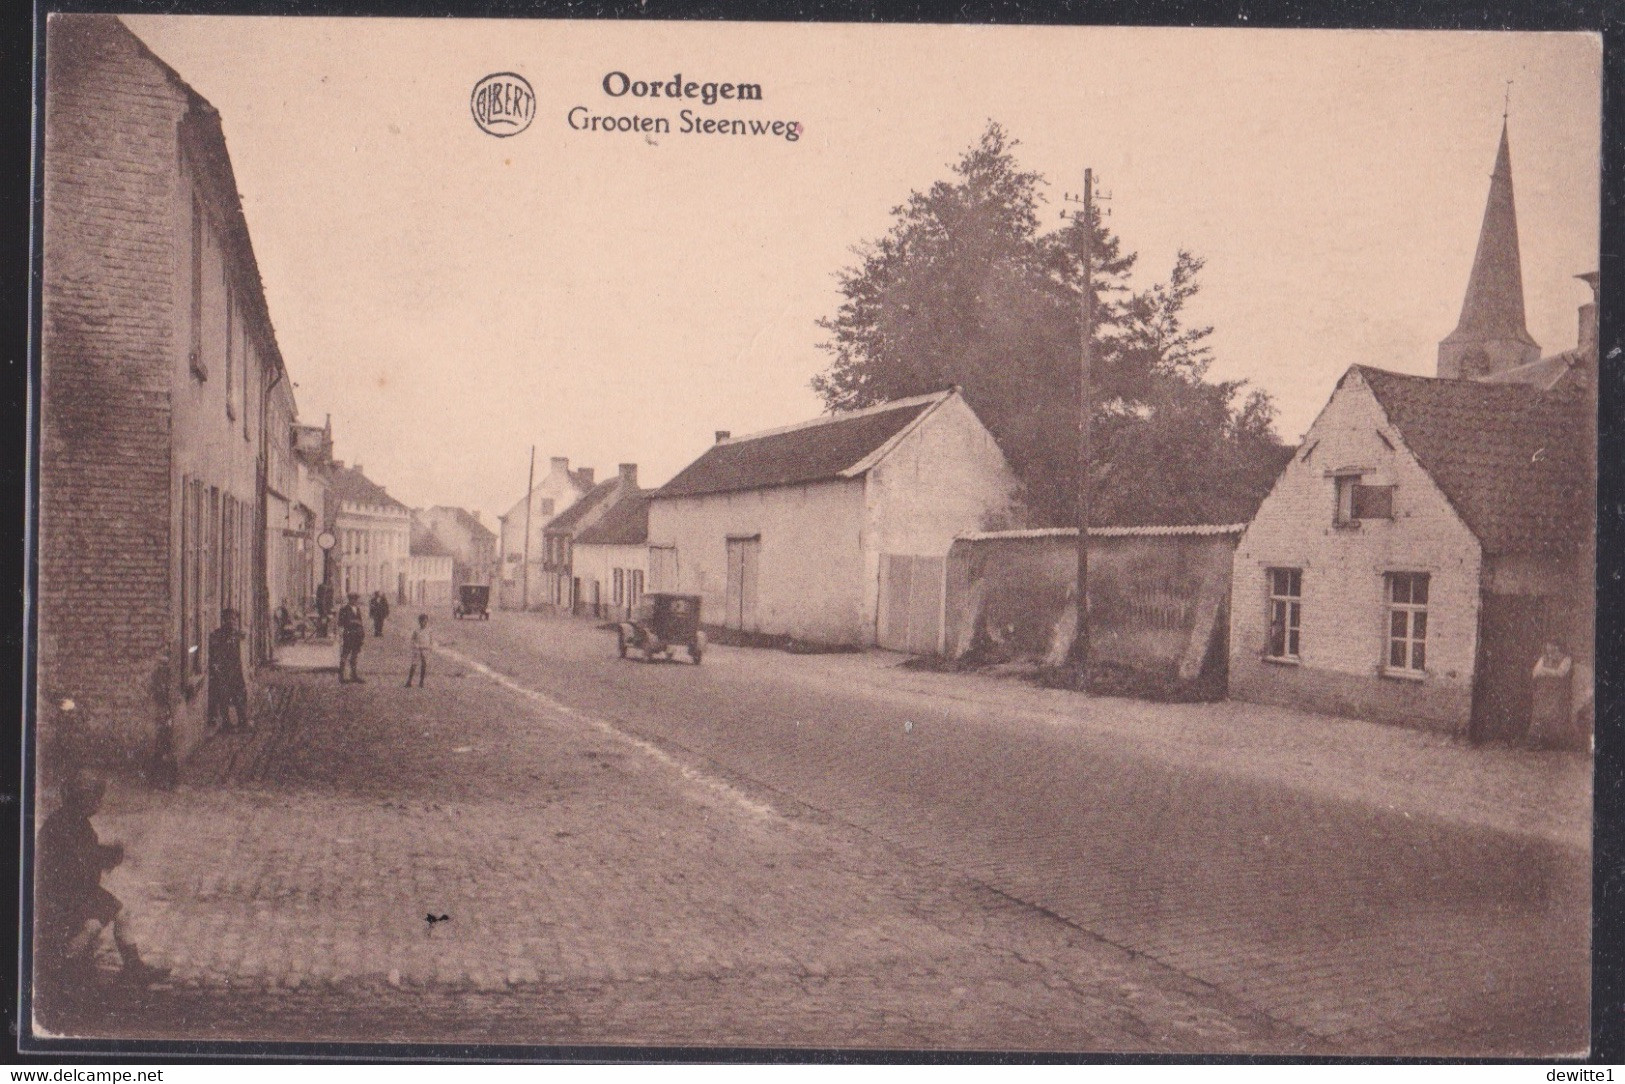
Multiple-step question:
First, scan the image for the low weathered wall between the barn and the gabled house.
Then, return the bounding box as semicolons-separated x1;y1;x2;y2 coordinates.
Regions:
944;525;1243;683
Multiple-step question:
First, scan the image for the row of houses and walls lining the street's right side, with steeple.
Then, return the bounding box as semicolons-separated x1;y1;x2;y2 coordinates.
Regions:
502;118;1597;738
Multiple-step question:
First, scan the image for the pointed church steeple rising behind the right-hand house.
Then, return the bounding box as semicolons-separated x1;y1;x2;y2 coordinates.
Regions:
1438;117;1541;377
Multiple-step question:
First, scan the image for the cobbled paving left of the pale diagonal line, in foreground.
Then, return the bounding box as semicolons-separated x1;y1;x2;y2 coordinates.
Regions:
28;621;1293;1051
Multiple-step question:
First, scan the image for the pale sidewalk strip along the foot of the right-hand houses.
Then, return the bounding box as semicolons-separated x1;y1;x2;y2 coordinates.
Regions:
744;650;1593;853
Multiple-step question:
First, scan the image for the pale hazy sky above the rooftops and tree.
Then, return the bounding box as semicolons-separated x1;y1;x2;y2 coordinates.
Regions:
125;16;1601;525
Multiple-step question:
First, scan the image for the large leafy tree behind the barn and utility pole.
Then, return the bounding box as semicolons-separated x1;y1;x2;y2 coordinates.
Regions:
813;122;1281;525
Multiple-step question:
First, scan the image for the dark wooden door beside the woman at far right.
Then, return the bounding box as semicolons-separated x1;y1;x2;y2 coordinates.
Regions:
1469;595;1545;741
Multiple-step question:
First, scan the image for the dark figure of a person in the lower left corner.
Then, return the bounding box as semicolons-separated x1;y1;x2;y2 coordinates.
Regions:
36;772;169;986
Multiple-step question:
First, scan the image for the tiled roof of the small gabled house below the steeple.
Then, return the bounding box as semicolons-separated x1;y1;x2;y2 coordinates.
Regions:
1355;366;1593;554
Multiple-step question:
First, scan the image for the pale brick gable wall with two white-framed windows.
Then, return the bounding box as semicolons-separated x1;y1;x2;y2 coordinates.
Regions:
1230;375;1482;733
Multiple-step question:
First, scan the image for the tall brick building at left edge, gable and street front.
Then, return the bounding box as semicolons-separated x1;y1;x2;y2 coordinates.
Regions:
36;15;297;780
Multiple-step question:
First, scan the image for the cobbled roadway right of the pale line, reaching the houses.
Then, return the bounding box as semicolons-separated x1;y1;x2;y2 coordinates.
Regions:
425;616;1591;1055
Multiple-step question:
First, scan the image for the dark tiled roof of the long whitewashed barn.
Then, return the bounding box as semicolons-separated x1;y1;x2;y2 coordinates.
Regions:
655;392;951;497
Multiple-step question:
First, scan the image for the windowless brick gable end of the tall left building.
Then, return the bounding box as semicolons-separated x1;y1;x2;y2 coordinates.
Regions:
37;15;185;780
